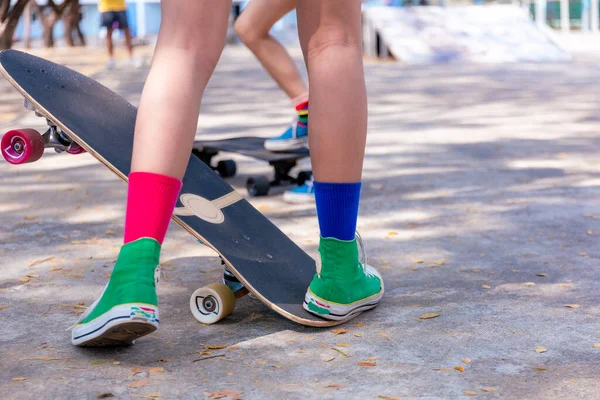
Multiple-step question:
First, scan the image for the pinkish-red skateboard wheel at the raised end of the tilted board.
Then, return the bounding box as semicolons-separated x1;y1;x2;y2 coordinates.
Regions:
0;129;45;165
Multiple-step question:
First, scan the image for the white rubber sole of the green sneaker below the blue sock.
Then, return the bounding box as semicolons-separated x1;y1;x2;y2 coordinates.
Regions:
303;265;384;321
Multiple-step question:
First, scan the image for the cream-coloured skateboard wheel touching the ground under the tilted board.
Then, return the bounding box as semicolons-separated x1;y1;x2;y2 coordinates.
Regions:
190;282;235;325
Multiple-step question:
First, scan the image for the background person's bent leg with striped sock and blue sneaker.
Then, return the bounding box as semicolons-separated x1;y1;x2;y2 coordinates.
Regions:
235;0;308;151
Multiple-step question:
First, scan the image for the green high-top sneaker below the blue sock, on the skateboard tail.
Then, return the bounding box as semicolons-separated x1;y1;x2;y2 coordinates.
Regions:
304;238;383;320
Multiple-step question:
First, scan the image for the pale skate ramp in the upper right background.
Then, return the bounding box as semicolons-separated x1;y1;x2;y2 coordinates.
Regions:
364;5;570;64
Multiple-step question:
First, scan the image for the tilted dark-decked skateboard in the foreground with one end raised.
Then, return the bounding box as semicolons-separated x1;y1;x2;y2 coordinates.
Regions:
0;50;358;327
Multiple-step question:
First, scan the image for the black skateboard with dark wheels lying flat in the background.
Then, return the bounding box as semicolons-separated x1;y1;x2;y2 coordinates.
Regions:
192;137;312;196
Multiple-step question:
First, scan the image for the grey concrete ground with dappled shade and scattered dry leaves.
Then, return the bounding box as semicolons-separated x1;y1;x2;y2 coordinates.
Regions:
0;38;600;400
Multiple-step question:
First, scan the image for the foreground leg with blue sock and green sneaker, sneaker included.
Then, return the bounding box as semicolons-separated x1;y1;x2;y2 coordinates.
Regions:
298;0;383;319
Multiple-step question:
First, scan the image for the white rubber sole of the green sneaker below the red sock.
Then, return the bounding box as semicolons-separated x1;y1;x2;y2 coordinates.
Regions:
71;303;159;347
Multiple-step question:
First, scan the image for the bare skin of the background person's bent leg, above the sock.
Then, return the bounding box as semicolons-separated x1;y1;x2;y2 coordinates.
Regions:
235;0;308;99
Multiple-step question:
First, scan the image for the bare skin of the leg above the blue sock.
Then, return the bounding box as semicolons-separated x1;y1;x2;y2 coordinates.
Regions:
298;0;367;183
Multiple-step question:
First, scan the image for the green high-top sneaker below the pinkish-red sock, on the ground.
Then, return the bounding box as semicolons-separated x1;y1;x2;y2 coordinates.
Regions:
71;238;160;346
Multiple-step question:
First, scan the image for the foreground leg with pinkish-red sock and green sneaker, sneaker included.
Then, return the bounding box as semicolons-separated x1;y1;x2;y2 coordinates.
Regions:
72;0;231;346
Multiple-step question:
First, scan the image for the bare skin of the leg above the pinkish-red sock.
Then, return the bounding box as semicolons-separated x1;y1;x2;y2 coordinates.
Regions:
131;0;231;179
